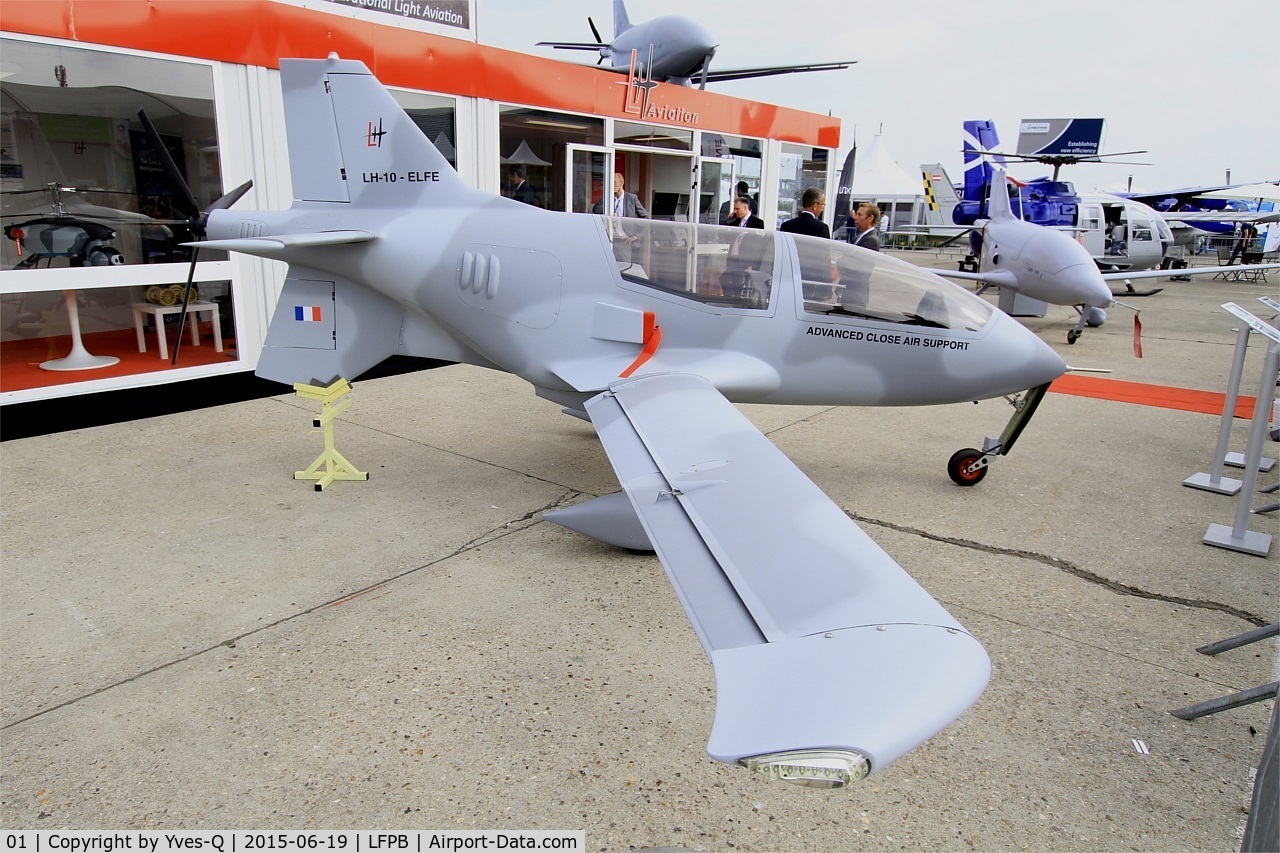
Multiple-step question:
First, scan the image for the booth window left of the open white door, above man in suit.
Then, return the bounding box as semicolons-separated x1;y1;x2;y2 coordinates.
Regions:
498;106;604;210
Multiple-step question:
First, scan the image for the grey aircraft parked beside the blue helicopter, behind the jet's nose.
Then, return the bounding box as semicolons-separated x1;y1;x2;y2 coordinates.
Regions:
938;169;1280;343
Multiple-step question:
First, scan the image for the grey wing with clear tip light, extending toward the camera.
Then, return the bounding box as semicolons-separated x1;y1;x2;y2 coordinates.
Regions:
586;373;991;786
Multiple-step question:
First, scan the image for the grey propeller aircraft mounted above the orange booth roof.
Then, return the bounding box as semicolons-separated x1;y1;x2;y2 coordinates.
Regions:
538;0;856;88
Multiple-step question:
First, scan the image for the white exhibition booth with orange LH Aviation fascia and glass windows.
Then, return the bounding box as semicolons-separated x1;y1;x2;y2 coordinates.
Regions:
0;0;840;405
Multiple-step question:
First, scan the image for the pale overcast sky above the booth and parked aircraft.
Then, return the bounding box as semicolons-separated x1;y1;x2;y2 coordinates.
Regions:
476;0;1280;192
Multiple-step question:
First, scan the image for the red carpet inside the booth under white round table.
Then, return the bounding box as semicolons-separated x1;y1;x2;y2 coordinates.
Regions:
0;323;237;392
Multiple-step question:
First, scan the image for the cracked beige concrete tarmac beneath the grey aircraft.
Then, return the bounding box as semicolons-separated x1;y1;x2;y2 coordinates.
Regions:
0;262;1280;850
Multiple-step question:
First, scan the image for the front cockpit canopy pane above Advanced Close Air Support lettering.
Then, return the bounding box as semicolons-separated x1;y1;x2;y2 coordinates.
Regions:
787;234;992;332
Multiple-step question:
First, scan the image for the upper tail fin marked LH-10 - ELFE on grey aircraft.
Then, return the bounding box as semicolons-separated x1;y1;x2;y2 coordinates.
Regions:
280;54;479;209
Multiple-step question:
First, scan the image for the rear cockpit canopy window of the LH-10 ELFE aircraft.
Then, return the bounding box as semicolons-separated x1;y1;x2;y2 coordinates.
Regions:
602;216;774;309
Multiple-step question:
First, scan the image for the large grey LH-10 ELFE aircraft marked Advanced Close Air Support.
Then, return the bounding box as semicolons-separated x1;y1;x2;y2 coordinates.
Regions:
170;56;1066;788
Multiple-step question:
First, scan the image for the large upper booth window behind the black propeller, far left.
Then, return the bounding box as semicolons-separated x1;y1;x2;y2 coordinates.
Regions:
0;38;225;269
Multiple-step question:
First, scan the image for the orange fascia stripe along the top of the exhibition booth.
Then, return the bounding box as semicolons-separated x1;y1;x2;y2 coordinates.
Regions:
0;0;840;149
